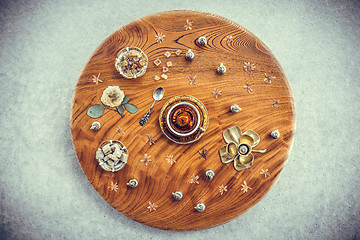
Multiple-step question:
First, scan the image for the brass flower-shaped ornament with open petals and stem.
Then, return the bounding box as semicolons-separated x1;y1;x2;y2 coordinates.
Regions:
219;126;266;171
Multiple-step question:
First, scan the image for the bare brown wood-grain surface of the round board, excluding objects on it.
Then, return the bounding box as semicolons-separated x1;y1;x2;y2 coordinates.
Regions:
71;11;295;231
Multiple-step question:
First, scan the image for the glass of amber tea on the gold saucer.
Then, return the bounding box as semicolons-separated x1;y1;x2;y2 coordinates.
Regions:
166;102;200;136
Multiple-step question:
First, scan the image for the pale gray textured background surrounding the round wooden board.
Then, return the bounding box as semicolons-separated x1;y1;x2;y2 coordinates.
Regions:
0;0;360;240
